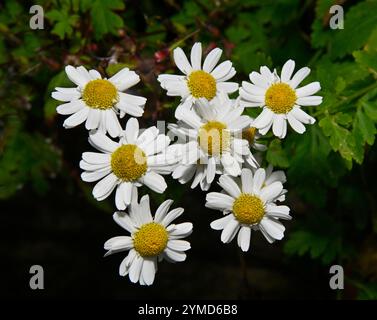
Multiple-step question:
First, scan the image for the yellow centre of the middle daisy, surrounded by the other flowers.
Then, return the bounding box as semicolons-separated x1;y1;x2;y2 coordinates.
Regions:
198;121;230;156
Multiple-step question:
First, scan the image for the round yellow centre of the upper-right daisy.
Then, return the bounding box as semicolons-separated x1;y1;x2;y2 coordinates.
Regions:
265;83;297;113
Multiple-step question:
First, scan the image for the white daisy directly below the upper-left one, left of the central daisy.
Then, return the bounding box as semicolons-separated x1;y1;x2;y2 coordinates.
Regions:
80;118;177;210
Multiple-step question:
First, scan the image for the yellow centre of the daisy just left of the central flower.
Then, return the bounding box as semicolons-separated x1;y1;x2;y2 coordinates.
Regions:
111;144;147;181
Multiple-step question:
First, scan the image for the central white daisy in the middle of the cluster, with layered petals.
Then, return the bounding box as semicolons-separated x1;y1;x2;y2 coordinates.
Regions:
168;98;257;190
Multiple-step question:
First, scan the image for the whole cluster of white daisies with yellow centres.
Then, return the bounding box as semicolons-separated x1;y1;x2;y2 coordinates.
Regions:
52;43;322;285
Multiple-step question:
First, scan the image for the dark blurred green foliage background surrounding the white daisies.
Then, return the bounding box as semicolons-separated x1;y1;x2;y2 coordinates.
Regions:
0;0;377;299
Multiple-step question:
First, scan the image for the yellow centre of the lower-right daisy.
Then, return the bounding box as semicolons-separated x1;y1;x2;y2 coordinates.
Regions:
233;193;264;224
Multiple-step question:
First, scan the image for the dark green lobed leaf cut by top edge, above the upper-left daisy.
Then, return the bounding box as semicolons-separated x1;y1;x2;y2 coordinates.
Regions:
90;0;124;40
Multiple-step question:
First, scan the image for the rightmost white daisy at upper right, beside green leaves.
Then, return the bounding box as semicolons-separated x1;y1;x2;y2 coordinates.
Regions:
240;60;322;139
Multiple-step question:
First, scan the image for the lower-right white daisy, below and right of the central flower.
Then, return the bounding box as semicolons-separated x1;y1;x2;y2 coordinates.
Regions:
206;168;291;251
